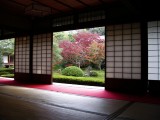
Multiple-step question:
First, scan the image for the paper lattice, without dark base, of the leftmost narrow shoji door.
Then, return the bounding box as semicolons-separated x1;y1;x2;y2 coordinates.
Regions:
15;36;30;73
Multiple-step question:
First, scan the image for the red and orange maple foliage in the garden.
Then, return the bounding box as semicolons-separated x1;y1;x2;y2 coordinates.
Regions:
60;31;104;68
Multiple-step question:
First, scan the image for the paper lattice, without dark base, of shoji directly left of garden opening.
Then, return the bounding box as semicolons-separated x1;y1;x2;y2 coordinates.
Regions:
33;33;52;75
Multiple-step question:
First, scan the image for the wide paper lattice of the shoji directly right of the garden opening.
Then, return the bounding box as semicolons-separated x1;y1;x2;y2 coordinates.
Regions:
106;23;141;79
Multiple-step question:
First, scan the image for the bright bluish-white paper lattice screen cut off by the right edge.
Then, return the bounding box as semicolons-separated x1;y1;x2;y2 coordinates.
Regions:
148;21;160;80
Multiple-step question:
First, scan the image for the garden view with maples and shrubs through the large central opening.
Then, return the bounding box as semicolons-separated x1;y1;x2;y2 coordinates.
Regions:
53;27;105;86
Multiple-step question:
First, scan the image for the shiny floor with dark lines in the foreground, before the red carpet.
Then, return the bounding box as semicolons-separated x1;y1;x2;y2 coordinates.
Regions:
0;85;160;120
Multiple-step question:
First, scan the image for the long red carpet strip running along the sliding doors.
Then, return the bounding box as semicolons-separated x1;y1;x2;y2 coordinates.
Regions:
0;78;160;104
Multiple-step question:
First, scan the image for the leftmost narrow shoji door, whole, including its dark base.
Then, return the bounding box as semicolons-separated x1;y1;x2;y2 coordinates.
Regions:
14;36;30;81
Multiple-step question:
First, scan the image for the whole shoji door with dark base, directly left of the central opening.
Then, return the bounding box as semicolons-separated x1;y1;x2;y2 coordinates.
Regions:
32;33;53;83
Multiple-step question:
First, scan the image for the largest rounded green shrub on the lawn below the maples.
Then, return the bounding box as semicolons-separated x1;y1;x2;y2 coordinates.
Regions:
62;66;83;77
